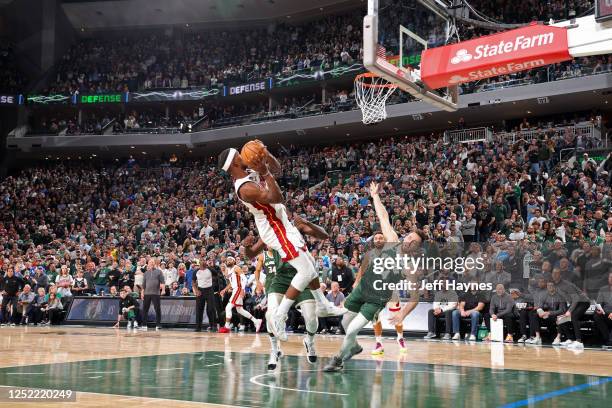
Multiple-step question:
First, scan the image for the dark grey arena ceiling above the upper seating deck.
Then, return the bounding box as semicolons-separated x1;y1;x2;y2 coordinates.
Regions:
58;0;358;30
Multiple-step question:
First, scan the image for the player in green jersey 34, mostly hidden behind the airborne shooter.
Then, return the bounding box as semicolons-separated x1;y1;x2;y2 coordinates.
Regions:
245;216;329;370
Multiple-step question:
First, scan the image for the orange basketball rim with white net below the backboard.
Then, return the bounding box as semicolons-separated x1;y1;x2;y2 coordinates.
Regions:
355;72;397;125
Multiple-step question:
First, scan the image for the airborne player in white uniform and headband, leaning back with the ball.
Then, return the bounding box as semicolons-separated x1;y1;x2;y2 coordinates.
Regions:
219;148;346;341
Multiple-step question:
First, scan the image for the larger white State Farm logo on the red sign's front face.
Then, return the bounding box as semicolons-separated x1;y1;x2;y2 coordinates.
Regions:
450;32;555;65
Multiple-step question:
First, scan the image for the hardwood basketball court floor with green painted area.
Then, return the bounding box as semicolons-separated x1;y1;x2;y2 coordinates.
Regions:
0;326;612;408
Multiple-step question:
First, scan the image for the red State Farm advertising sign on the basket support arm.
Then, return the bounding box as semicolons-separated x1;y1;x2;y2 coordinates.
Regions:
421;24;572;89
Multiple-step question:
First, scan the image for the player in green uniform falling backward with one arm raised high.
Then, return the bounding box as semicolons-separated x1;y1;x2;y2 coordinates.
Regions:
323;182;424;372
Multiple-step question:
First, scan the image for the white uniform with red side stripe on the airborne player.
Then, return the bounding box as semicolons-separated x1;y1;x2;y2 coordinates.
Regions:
234;170;306;261
